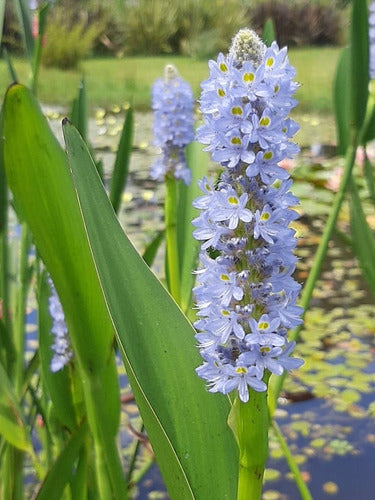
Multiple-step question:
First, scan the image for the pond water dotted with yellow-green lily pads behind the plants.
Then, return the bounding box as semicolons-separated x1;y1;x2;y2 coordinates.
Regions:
23;104;375;500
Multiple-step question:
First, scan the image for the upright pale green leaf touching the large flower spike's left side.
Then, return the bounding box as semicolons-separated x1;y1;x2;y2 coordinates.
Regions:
177;142;208;313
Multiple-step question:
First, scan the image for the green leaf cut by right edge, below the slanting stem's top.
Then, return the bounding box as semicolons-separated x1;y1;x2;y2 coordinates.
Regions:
350;181;375;298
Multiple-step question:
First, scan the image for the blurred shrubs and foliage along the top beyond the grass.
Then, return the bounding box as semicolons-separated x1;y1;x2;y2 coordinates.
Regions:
3;0;350;64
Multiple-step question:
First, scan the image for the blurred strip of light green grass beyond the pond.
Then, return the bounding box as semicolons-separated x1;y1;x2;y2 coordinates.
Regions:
0;47;340;113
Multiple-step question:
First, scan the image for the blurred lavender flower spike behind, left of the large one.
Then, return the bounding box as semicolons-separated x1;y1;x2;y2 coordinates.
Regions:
150;64;194;184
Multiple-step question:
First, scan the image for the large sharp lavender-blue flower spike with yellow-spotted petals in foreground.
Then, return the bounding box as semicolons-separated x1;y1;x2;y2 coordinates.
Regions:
193;29;303;402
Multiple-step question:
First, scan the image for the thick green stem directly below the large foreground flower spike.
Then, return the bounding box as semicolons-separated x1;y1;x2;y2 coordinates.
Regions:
228;380;269;500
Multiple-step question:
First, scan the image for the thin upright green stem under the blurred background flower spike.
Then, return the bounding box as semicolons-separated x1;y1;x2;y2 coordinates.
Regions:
164;175;181;304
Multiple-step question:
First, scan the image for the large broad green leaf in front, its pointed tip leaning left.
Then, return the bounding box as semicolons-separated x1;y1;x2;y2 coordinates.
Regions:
61;124;238;500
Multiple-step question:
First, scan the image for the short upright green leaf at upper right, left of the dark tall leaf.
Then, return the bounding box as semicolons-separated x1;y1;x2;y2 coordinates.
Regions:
333;48;350;155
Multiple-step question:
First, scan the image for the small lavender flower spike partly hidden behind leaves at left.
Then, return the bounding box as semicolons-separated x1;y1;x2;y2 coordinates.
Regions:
48;279;73;372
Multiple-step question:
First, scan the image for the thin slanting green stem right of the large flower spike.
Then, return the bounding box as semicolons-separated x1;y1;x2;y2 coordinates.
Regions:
269;141;358;417
